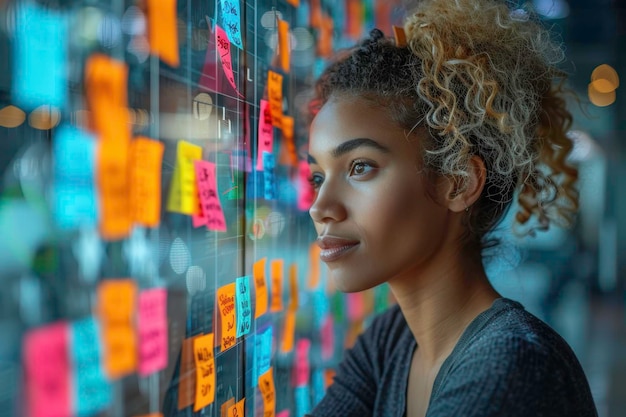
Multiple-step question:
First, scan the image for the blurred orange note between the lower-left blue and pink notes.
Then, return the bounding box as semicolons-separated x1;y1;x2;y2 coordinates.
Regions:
98;279;137;378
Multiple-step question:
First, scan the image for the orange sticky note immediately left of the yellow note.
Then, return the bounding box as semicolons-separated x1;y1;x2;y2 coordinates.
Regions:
130;136;164;227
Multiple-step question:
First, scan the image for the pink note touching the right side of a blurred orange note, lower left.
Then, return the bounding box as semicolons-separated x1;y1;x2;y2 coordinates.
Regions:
138;288;167;376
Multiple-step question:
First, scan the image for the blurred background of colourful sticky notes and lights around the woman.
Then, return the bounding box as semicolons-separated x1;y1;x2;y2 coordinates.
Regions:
0;0;626;417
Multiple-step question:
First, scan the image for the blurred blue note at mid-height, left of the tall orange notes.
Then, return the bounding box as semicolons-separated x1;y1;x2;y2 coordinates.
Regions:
52;125;99;230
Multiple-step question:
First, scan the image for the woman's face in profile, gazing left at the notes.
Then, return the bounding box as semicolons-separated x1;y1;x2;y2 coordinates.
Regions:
309;98;450;292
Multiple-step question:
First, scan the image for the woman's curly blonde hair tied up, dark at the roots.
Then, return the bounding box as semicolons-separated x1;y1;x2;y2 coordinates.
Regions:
310;0;578;245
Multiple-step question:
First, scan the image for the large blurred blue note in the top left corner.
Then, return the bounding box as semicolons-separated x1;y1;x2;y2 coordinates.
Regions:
12;2;69;110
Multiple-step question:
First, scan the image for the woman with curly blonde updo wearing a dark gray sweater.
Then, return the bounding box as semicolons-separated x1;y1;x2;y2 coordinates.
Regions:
309;0;597;417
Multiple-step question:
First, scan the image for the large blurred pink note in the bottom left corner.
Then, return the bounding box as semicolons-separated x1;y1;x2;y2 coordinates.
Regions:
23;322;72;417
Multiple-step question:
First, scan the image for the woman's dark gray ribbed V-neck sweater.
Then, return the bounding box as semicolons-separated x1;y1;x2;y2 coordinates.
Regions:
311;298;597;417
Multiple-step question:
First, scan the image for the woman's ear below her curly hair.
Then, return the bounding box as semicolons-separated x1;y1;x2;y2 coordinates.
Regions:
447;155;487;213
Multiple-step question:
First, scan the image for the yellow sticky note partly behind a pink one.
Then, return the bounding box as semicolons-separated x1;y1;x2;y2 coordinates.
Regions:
167;140;202;215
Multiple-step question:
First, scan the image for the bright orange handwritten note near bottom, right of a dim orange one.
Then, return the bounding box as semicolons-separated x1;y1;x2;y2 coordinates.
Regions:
193;333;215;411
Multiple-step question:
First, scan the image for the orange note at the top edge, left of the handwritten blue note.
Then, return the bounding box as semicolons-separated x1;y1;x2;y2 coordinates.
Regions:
147;0;180;67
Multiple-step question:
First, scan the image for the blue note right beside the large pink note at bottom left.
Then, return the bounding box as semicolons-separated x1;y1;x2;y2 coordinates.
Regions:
71;317;113;417
